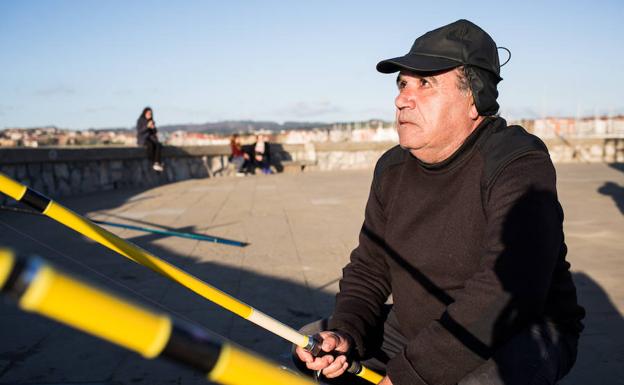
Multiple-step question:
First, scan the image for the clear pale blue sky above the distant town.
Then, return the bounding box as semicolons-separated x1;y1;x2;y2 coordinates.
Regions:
0;0;624;128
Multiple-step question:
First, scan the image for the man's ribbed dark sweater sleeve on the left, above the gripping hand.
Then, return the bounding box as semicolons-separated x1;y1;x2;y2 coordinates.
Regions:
329;174;390;357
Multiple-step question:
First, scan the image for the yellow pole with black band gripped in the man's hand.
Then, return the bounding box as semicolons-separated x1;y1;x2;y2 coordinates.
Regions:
0;172;383;384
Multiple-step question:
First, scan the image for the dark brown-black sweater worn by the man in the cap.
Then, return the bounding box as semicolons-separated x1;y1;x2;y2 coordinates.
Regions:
330;118;584;385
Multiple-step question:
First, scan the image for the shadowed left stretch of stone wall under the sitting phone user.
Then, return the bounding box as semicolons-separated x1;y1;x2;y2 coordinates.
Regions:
0;146;229;204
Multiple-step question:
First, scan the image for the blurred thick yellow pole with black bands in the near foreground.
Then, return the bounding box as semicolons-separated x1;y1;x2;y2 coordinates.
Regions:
0;249;315;385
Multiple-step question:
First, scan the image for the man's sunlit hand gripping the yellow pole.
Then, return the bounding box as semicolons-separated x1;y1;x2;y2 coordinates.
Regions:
295;331;351;378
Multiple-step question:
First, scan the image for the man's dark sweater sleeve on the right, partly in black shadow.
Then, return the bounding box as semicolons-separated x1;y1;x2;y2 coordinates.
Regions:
387;153;565;385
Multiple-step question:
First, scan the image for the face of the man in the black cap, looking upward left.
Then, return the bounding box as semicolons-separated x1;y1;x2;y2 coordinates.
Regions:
395;69;480;163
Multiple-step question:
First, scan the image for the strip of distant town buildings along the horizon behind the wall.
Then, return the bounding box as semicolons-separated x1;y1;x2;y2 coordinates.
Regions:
0;115;624;147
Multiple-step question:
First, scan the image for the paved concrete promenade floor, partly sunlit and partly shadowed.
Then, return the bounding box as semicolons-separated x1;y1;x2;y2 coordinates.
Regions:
0;164;624;385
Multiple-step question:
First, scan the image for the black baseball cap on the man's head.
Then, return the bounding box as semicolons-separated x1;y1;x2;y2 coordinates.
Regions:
377;19;501;80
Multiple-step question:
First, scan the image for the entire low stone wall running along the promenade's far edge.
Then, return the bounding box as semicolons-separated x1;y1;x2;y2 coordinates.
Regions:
0;138;624;204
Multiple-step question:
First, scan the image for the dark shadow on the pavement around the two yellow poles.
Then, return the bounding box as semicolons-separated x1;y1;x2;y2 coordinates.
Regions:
0;219;333;384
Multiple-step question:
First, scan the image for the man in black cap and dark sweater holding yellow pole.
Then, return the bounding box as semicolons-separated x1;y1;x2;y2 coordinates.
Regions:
296;20;584;385
